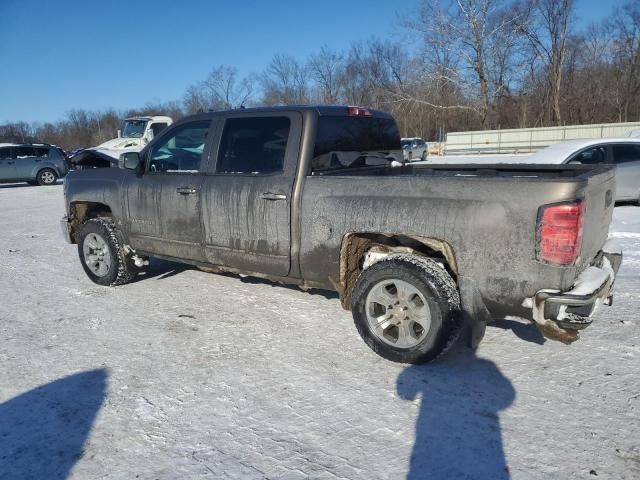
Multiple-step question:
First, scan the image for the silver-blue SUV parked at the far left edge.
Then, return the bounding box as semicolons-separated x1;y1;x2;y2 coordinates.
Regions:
0;143;69;185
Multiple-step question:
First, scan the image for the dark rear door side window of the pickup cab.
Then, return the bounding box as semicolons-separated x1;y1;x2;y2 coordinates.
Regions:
216;117;291;175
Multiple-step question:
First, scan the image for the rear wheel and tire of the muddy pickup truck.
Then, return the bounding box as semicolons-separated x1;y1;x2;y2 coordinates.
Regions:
351;254;462;363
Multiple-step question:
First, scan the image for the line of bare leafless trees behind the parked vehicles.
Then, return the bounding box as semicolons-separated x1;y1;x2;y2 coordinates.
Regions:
0;0;640;148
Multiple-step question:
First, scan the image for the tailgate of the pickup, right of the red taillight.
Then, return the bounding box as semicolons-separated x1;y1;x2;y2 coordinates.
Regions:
576;168;615;272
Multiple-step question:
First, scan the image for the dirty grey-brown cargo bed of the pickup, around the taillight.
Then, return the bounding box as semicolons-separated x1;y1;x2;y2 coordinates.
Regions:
301;164;615;316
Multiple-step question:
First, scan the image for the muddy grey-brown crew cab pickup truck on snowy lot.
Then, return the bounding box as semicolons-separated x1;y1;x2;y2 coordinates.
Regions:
62;106;622;363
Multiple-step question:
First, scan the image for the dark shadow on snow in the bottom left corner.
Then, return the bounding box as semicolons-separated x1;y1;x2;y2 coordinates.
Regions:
0;369;107;480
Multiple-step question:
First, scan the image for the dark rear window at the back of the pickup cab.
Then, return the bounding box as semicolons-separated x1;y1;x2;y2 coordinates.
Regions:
311;115;403;175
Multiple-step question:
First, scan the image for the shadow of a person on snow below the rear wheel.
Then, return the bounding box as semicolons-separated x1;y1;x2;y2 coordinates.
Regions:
397;349;515;480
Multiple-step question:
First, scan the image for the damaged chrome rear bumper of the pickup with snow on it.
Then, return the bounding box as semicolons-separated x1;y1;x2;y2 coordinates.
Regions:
532;240;622;343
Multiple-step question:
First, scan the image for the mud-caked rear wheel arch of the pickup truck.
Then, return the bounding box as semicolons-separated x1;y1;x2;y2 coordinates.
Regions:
339;232;458;310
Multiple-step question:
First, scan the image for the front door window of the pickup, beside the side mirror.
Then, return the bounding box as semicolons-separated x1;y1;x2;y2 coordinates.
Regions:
147;120;211;173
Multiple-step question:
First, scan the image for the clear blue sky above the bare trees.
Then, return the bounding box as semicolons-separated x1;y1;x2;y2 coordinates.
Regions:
0;0;623;123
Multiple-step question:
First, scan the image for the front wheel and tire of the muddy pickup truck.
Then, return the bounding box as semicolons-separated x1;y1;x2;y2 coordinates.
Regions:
78;217;137;286
